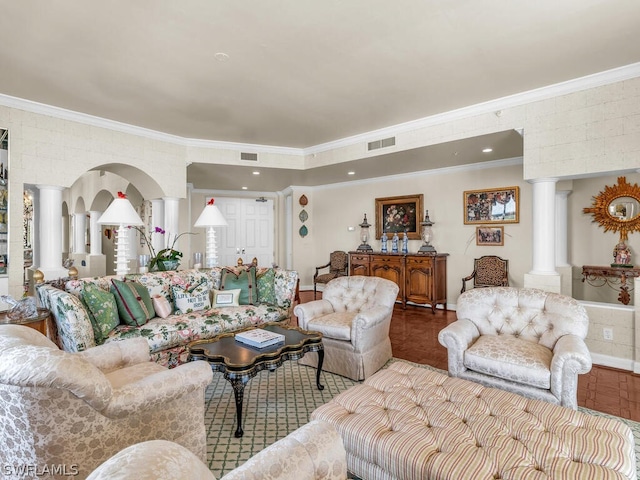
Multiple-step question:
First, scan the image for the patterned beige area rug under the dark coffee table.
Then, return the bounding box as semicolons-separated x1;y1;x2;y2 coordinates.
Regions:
205;360;640;479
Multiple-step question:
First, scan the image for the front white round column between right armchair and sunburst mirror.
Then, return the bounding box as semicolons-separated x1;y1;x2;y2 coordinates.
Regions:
524;178;560;292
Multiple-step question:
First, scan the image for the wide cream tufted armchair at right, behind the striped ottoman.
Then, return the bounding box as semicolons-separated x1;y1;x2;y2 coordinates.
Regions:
438;287;591;409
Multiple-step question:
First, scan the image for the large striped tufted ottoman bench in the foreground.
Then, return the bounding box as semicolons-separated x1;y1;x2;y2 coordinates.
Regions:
311;362;636;480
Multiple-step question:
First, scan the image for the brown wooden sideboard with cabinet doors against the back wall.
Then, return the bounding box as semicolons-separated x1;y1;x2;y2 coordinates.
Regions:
349;252;449;313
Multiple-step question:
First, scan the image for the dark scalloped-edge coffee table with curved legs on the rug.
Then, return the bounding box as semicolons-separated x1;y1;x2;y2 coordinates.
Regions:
187;323;324;438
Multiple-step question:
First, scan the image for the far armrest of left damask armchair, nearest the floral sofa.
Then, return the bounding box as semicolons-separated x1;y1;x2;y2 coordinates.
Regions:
78;337;151;373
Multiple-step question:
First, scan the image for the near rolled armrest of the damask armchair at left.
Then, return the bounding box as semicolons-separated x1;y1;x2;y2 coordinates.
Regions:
101;361;213;418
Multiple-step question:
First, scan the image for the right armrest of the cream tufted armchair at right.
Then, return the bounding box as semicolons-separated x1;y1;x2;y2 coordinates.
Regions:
551;335;592;410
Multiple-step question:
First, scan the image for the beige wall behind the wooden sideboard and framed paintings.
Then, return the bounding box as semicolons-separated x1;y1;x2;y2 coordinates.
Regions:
294;160;531;304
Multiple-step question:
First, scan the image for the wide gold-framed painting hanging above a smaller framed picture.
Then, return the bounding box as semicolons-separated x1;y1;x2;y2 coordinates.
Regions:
463;187;520;225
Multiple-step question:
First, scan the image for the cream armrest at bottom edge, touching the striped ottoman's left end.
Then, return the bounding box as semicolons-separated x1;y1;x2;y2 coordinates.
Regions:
221;420;347;480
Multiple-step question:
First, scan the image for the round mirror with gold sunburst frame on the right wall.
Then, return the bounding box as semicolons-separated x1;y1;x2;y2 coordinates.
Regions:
583;177;640;243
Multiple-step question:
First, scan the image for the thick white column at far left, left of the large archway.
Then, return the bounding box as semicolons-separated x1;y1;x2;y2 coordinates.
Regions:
36;185;68;280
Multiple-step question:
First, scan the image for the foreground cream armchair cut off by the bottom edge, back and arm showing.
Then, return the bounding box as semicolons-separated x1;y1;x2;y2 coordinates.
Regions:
88;420;347;480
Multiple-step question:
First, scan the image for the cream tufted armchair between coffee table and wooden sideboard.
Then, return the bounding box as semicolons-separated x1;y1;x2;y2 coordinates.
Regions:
293;275;398;380
